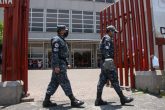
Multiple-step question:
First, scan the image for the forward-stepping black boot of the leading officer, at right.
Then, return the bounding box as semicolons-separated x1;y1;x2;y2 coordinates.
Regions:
119;92;133;105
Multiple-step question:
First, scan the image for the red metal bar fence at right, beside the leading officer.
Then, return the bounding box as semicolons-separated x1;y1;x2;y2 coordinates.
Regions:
100;0;165;88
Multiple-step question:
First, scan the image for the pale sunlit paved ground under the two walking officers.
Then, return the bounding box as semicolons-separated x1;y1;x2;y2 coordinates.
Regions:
0;69;165;110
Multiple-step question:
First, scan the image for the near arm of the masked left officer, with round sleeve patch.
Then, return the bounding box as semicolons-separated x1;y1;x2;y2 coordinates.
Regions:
51;39;60;69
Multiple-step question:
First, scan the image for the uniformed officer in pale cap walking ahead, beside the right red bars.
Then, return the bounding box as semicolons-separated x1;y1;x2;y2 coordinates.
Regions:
95;25;133;106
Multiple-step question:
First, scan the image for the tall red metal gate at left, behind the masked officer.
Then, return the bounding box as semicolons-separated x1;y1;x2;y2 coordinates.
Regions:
0;0;29;93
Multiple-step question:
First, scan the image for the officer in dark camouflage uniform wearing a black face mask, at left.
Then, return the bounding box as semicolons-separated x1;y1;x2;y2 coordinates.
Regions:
43;25;84;107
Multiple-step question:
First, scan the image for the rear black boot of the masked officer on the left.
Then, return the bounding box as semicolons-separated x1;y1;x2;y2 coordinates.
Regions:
42;94;57;107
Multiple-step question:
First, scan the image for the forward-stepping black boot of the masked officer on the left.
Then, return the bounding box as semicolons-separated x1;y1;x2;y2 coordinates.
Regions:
68;94;84;107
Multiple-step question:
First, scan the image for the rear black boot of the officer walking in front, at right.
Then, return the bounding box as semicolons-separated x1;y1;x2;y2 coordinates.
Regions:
95;92;108;106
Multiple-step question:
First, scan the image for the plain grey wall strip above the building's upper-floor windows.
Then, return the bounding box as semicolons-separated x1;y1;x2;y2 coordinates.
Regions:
30;0;109;11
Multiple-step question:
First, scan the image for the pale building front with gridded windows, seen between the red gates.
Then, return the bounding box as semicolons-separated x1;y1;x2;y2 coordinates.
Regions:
28;0;114;69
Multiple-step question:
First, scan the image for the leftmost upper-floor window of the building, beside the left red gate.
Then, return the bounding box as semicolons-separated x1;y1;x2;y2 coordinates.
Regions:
29;9;44;32
